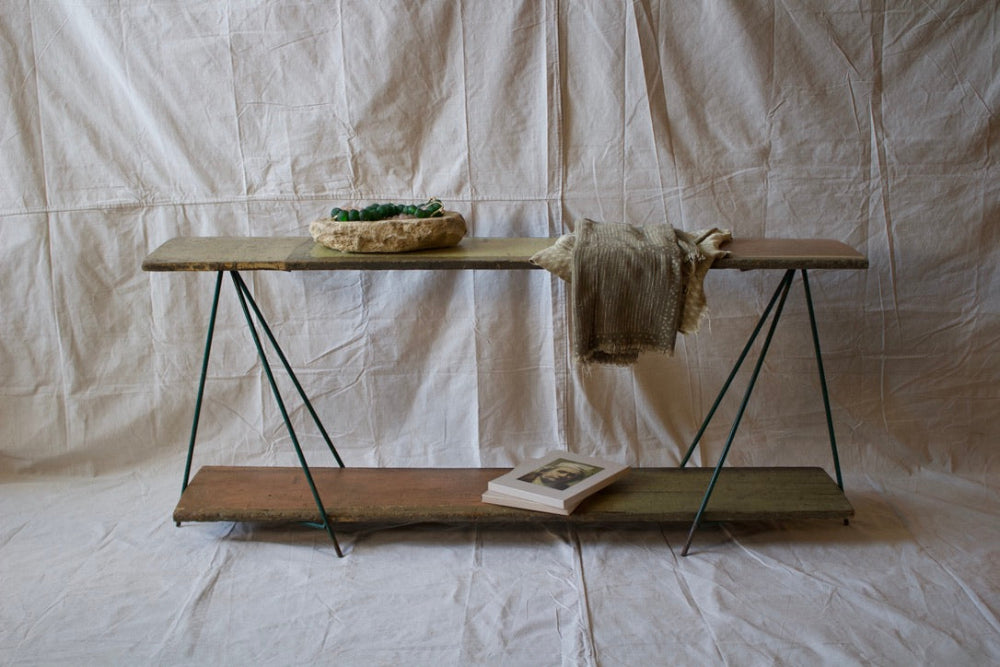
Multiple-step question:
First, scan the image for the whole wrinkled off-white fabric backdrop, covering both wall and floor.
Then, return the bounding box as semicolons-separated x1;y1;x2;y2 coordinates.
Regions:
0;0;1000;664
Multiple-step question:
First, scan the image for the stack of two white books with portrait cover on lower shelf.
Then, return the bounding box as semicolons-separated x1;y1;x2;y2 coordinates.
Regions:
483;452;628;515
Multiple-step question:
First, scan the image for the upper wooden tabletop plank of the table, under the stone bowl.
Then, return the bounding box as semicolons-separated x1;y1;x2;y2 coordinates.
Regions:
142;236;868;271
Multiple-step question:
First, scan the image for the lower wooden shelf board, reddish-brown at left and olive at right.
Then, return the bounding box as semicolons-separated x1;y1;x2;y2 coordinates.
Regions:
173;466;854;528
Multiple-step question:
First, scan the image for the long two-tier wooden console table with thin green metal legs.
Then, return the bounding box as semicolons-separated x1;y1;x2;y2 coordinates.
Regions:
142;237;868;556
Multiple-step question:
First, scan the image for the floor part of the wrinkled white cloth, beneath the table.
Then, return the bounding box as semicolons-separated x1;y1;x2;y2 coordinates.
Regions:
0;460;1000;665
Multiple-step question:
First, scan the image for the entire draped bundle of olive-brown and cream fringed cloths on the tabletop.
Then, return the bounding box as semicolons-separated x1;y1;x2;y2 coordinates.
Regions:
531;218;732;365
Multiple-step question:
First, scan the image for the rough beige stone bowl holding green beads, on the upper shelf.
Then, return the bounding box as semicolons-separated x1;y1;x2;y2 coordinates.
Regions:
309;211;467;252
